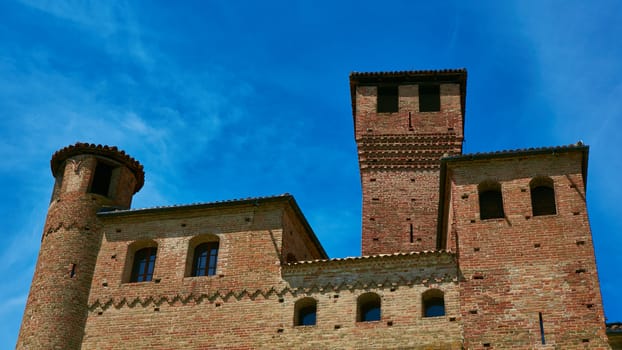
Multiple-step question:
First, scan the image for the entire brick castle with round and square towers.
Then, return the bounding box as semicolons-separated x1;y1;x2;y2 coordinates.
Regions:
17;69;615;349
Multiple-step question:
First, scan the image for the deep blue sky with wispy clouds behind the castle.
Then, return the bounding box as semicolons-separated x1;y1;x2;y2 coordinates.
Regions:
0;0;622;349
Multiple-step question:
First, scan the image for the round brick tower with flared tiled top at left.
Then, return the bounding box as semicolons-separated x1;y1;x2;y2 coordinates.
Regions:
17;143;145;349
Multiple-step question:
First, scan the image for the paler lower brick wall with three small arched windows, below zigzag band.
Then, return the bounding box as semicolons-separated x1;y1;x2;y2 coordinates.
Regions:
83;253;461;349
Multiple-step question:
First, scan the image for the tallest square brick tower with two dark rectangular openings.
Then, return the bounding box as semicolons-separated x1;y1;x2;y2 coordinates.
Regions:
350;69;467;255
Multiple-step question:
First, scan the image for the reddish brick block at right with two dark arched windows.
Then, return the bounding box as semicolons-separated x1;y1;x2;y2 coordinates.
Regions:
448;149;608;349
